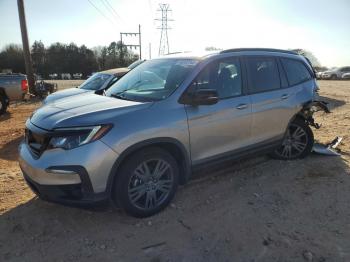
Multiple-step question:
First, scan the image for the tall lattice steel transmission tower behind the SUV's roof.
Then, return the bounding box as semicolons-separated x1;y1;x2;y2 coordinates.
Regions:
155;4;174;55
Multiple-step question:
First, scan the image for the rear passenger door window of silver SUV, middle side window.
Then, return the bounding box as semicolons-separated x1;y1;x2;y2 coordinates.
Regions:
247;57;281;93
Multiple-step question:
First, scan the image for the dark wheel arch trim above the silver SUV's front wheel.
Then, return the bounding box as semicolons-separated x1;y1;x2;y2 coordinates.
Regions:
107;137;191;194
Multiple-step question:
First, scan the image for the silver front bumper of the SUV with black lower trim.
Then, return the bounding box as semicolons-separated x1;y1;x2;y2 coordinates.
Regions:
19;138;118;204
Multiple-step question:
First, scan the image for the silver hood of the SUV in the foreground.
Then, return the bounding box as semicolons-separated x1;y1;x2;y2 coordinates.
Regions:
30;94;153;130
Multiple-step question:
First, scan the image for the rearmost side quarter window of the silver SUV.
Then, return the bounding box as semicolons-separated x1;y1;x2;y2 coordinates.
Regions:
281;58;312;86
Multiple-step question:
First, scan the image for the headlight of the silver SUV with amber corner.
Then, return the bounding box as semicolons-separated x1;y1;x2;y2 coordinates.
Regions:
48;125;112;150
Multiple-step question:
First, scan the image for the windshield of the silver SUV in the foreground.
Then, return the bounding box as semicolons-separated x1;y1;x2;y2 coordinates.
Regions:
106;58;198;102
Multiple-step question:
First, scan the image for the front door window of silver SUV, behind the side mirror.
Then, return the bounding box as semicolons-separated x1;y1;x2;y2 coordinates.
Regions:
195;59;242;99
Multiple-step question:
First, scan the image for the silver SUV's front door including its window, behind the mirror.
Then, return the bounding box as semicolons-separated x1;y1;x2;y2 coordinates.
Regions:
185;57;251;164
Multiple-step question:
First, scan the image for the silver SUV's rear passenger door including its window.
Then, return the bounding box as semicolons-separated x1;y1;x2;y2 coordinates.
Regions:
244;56;296;143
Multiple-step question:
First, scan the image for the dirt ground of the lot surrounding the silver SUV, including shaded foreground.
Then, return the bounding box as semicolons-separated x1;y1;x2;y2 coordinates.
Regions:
0;81;350;262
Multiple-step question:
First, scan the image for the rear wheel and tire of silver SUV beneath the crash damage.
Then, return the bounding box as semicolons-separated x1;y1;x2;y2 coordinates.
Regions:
271;118;314;160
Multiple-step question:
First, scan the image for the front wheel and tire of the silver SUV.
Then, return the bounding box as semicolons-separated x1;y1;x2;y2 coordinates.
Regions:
112;147;179;217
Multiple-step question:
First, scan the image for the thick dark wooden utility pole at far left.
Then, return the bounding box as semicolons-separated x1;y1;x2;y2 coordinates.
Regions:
17;0;35;94
